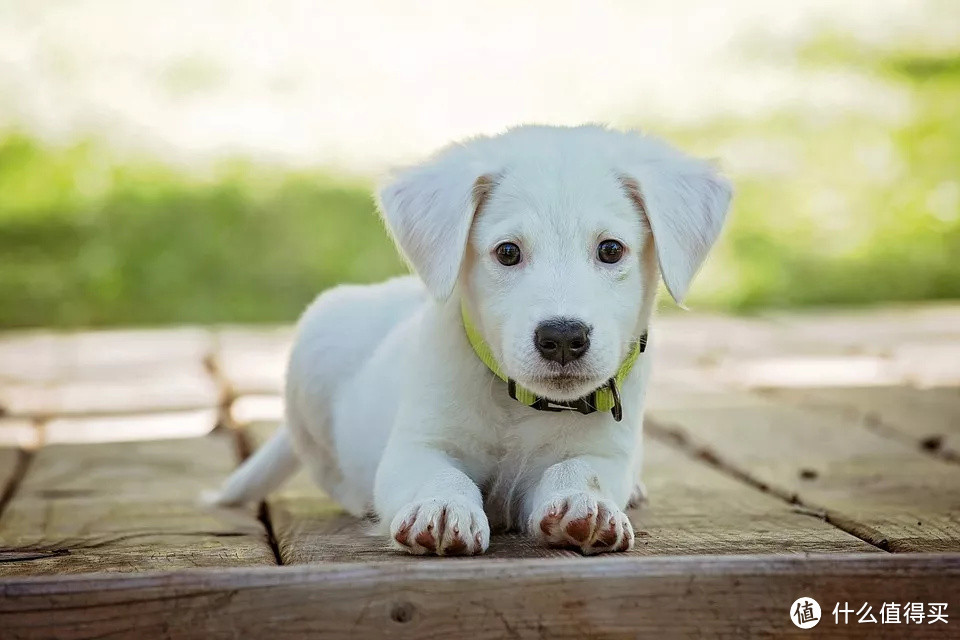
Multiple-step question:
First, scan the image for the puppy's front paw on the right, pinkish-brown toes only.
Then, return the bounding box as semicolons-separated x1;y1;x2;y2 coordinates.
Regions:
529;493;633;555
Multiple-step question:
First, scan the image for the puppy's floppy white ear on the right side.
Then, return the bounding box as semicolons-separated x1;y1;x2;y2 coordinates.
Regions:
621;152;733;303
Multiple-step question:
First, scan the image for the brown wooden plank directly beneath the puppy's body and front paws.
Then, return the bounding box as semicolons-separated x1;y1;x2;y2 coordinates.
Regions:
249;423;878;564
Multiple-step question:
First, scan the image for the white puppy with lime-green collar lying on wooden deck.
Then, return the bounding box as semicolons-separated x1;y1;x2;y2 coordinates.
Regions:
219;126;731;555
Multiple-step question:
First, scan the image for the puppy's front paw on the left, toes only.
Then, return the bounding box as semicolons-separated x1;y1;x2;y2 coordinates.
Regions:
390;498;490;556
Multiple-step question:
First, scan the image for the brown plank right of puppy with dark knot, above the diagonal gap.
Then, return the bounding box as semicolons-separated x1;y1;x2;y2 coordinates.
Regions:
647;392;960;552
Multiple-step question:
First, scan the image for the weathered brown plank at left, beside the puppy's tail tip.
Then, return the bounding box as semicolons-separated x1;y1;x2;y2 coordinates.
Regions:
0;436;274;575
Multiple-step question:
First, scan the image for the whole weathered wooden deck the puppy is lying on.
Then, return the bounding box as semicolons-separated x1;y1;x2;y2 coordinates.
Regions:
0;305;960;640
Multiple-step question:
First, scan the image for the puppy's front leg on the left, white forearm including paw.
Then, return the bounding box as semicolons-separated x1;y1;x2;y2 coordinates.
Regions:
375;444;490;556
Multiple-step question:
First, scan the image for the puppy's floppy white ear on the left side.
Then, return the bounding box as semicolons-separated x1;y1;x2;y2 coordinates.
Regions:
378;146;493;299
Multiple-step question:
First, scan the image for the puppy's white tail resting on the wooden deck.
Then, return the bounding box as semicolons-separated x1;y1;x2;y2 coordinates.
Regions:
208;426;300;507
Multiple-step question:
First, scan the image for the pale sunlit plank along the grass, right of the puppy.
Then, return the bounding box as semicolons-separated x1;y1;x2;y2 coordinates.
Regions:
654;304;960;388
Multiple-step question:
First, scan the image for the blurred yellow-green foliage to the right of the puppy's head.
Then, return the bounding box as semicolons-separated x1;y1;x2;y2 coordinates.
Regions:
668;38;960;311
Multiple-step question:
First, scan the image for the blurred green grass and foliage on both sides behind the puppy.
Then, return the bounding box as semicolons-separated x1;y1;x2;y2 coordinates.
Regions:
0;3;960;328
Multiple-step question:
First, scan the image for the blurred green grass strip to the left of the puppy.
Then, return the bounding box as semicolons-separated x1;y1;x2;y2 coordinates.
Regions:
0;136;402;327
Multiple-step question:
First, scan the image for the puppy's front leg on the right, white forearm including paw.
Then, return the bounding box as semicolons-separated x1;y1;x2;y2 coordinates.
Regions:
527;456;633;554
